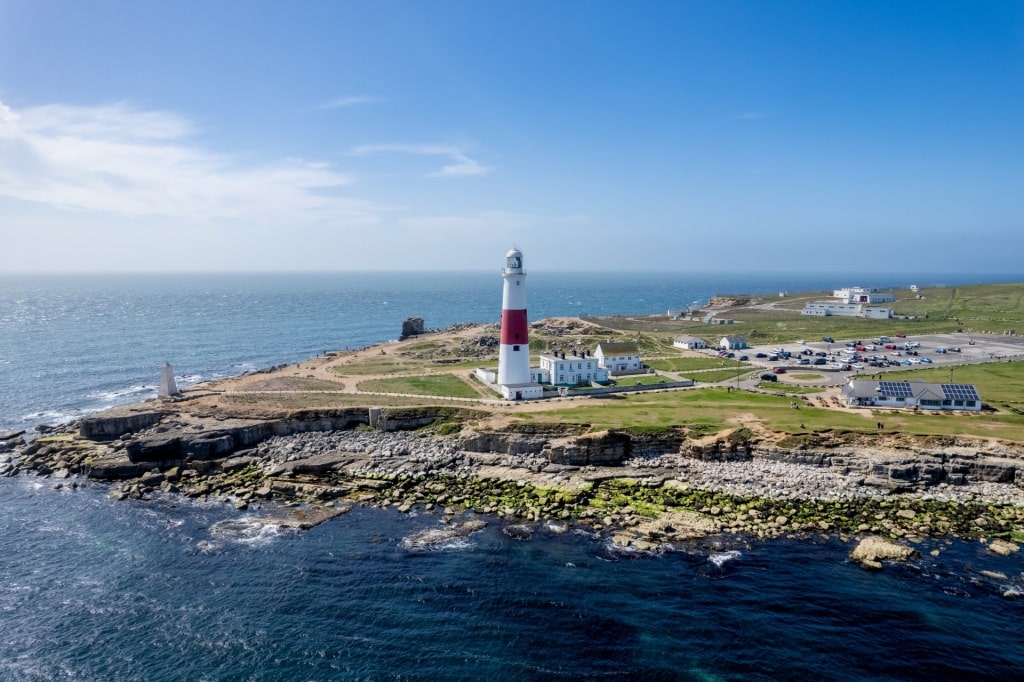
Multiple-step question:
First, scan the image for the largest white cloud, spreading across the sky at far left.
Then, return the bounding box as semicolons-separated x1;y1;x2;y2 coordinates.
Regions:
0;102;381;224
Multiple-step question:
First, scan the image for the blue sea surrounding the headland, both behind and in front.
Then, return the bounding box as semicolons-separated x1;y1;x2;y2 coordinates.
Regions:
0;270;1024;681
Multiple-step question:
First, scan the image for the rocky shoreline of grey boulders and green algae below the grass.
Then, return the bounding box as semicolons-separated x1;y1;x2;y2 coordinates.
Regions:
0;406;1024;567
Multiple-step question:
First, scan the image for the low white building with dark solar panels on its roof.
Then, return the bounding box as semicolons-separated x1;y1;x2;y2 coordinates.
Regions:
843;379;981;410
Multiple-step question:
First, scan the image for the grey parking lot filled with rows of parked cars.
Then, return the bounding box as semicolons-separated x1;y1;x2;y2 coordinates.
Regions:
712;333;1024;385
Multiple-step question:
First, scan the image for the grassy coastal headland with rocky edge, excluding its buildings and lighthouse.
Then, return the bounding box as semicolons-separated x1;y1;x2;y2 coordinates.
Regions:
6;278;1024;567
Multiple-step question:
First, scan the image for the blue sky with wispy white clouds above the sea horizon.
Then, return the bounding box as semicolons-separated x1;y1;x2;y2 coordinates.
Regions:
0;0;1024;272
